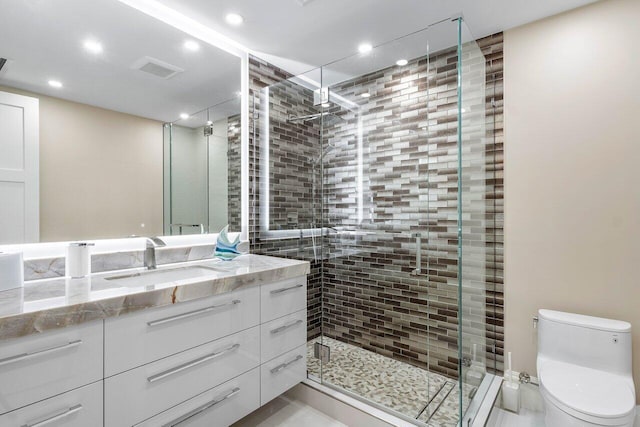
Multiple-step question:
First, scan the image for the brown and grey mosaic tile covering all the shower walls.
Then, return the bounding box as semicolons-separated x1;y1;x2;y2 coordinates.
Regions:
250;34;504;378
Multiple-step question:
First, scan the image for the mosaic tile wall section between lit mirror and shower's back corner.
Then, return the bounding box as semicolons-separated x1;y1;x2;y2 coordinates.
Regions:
249;57;322;339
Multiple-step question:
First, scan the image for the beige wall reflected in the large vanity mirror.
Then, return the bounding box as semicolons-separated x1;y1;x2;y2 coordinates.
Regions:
0;86;163;242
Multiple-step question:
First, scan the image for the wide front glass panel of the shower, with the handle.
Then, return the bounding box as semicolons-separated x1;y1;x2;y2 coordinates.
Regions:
321;20;458;426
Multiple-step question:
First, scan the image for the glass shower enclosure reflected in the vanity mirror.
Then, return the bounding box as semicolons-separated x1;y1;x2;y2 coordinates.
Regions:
163;98;241;235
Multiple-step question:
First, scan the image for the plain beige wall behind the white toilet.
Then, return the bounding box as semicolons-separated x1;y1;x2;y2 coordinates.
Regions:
504;0;640;396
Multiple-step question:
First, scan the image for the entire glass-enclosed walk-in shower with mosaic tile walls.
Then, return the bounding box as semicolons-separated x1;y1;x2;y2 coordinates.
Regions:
250;18;502;426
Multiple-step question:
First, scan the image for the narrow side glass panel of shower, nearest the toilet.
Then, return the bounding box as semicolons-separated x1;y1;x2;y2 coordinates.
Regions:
457;19;498;420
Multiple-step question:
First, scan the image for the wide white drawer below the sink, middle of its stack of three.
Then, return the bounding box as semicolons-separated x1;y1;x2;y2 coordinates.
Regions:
105;326;260;426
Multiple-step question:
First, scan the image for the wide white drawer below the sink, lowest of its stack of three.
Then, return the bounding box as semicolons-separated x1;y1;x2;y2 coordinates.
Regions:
134;368;260;427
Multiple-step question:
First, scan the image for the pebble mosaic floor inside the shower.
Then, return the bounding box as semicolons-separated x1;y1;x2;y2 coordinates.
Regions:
307;337;473;427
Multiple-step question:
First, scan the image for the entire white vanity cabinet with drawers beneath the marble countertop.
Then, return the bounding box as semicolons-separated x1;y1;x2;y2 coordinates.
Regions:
0;276;307;427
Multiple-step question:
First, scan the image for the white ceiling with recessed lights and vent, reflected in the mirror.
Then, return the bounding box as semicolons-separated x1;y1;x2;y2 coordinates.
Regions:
0;0;240;125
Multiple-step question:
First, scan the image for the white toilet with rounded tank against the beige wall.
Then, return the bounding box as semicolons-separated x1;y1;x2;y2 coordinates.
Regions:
537;310;636;427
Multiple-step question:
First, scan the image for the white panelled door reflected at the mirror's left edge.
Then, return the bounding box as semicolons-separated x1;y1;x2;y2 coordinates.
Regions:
0;92;40;244
